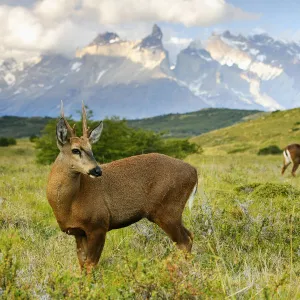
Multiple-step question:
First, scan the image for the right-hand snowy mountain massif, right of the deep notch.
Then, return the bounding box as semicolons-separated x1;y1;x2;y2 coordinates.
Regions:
174;31;300;110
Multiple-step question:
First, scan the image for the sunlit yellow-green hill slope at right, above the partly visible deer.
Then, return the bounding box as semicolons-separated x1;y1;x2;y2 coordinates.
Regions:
191;108;300;154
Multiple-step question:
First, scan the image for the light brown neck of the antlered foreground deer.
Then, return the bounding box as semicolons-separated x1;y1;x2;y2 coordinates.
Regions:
47;154;81;219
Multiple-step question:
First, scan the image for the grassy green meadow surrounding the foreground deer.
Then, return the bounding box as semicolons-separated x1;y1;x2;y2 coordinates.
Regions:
0;140;300;299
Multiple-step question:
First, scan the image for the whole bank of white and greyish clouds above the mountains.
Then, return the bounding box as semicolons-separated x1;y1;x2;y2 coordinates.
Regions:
0;0;256;58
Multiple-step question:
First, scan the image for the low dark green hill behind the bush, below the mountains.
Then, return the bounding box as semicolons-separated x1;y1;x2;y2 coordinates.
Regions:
128;108;259;137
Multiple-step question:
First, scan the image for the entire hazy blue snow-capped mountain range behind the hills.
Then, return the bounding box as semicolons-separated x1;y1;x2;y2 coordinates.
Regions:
0;25;300;119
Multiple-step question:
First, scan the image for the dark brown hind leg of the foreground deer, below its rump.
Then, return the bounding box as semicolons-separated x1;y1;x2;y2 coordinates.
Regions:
154;220;193;252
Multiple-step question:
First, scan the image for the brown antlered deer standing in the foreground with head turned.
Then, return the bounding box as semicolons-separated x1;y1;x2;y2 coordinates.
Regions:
47;105;198;272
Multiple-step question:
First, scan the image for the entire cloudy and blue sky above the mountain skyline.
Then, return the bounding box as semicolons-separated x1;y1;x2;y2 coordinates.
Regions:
0;0;300;60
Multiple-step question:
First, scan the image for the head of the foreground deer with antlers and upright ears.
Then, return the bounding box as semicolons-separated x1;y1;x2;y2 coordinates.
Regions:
56;103;103;178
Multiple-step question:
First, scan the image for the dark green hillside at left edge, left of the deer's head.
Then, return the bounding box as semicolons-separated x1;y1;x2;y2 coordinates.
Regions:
0;116;51;138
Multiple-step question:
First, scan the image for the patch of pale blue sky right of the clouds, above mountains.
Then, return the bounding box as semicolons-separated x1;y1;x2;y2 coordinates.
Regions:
159;0;300;41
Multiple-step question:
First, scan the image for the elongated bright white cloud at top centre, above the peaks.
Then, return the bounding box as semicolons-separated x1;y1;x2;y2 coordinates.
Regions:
83;0;257;26
